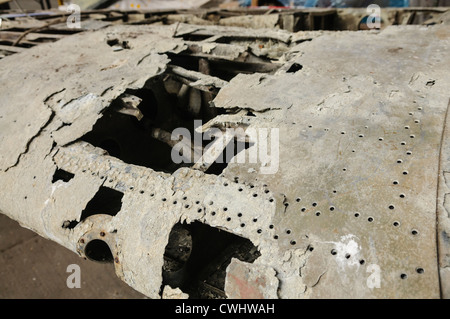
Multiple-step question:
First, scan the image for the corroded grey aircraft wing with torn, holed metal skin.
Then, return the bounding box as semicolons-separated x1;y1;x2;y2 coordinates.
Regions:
0;10;450;298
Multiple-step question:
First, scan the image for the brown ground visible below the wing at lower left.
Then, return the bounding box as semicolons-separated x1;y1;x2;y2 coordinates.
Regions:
0;214;145;299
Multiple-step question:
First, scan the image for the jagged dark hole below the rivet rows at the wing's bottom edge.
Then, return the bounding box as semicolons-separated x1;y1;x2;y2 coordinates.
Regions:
162;222;261;299
